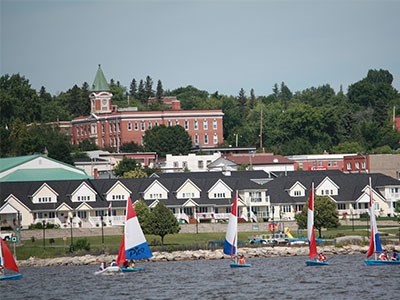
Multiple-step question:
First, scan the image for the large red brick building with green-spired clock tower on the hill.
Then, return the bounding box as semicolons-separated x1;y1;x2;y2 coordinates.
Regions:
71;65;224;150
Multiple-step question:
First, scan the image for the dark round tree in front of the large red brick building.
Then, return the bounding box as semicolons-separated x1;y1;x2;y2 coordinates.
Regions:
143;125;192;157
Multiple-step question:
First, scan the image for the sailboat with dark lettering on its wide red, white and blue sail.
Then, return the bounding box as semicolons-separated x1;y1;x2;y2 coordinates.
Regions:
117;197;153;272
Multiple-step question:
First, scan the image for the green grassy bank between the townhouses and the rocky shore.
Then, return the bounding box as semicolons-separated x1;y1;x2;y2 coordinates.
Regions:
8;226;399;260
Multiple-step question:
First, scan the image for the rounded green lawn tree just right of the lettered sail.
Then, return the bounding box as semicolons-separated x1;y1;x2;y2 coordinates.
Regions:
149;202;181;245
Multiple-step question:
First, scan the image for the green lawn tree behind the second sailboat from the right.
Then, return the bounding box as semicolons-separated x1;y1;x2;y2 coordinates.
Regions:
295;196;340;238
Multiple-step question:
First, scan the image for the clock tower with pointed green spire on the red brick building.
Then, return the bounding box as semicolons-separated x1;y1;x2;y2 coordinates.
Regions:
89;65;113;114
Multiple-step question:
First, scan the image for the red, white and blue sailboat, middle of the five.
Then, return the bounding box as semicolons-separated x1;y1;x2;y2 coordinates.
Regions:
224;192;251;268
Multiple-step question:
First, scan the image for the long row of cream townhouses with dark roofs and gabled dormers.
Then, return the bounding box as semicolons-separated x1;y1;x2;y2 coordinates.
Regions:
0;171;400;228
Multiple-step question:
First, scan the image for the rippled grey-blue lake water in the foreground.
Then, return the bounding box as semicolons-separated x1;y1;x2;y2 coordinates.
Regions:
0;255;400;300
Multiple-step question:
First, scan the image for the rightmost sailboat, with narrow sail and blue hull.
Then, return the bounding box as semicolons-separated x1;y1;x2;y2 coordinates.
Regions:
365;177;400;266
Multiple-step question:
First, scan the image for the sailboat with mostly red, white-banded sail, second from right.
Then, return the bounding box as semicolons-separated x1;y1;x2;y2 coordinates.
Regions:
306;182;329;266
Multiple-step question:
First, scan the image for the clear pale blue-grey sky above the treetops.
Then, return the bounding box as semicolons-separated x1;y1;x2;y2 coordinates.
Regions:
0;0;400;96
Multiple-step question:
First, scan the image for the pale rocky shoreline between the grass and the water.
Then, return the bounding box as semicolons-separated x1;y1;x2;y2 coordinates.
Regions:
18;245;400;267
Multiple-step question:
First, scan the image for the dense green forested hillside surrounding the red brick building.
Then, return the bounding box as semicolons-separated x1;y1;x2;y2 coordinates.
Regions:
0;70;400;162
